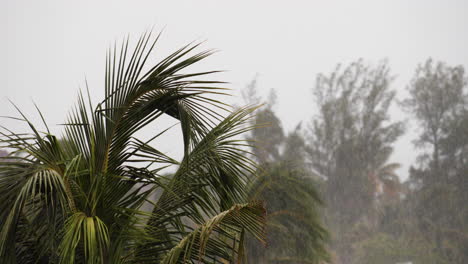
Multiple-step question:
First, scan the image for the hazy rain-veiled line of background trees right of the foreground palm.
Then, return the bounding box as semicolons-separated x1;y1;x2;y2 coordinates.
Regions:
246;59;468;264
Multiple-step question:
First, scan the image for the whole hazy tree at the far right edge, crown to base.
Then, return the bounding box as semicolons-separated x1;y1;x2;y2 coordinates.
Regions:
403;59;468;263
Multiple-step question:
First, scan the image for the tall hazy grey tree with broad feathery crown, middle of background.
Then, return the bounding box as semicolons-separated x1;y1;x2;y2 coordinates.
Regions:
308;60;403;263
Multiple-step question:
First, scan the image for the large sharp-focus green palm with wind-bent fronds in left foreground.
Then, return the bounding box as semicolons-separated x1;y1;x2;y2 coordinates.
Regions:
0;33;265;263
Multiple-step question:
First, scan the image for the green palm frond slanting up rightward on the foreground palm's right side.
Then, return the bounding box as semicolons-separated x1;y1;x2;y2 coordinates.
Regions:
133;108;262;259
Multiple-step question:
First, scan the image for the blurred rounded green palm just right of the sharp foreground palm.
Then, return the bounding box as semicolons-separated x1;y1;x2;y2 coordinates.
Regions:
247;160;330;264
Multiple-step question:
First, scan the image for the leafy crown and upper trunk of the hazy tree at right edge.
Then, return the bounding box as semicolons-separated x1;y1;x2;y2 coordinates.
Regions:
403;59;467;181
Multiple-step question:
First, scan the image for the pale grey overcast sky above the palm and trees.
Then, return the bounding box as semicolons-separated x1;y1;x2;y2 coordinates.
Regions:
0;0;468;179
